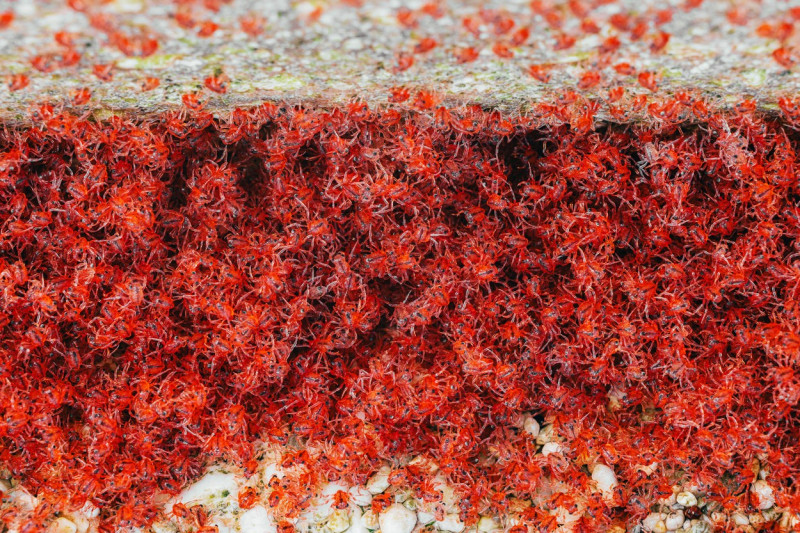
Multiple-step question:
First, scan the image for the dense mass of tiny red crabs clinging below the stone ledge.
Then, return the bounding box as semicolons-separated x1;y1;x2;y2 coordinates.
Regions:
0;92;800;531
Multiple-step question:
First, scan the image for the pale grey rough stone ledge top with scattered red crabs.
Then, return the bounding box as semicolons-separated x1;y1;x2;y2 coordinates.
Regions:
0;0;799;119
